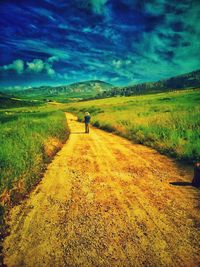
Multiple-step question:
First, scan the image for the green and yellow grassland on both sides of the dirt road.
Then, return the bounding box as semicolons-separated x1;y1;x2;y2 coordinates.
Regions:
0;90;200;205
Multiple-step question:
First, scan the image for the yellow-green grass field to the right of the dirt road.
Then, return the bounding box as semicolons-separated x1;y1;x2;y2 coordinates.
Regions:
68;90;200;162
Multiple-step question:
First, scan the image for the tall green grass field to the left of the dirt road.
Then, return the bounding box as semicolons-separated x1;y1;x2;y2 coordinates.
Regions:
0;105;69;207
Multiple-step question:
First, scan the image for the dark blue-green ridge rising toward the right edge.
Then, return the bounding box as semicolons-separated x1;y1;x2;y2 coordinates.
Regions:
97;70;200;98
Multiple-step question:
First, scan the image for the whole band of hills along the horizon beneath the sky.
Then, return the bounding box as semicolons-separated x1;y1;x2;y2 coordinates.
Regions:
1;70;200;102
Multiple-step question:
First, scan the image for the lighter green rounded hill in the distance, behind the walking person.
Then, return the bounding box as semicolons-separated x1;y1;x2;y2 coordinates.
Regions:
14;80;113;99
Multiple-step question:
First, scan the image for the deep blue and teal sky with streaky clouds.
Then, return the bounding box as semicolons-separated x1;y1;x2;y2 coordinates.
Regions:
0;0;200;88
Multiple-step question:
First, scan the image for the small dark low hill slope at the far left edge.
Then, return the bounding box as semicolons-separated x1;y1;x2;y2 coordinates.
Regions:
0;92;39;109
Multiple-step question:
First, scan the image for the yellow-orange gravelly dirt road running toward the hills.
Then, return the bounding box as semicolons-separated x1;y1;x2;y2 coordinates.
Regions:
4;114;200;267
